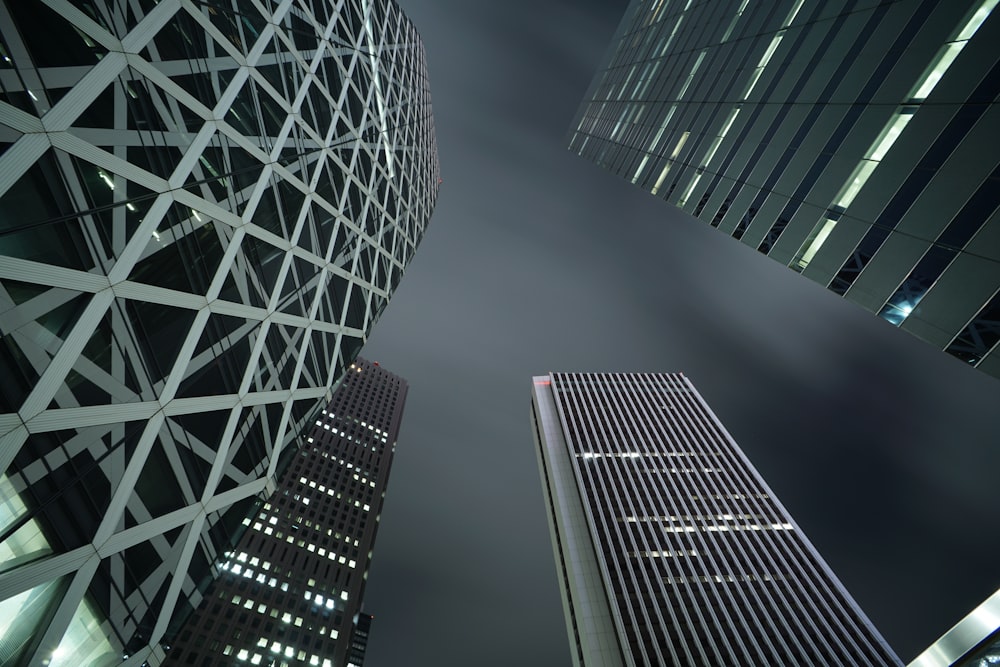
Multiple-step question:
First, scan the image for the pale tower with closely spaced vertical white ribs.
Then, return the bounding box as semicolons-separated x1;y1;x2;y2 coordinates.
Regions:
532;373;901;667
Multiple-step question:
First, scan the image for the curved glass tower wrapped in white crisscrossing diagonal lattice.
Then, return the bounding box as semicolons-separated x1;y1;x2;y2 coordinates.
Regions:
0;0;438;667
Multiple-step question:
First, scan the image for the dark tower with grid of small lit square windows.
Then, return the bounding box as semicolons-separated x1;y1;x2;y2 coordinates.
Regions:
166;358;407;667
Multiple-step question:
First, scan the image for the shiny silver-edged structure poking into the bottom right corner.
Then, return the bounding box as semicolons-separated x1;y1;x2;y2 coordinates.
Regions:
909;591;1000;667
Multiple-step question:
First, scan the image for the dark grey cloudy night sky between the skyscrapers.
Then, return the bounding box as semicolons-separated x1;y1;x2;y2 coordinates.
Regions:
363;0;1000;667
